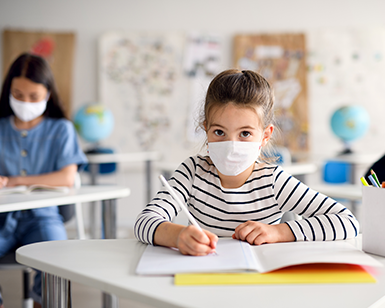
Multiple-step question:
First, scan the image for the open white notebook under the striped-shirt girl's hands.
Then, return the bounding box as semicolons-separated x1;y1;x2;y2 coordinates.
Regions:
136;238;383;275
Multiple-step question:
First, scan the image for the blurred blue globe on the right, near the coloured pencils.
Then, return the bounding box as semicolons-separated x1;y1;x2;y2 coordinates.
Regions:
330;105;370;153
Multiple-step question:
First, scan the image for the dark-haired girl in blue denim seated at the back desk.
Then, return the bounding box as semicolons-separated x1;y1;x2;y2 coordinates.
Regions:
0;54;86;306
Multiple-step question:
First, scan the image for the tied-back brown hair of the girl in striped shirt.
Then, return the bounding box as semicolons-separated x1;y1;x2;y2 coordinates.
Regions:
199;69;275;162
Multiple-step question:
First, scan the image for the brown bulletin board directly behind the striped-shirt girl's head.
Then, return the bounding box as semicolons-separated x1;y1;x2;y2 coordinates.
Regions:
233;33;309;154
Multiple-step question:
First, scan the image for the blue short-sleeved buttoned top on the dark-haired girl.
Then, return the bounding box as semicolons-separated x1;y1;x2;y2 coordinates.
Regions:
0;116;87;216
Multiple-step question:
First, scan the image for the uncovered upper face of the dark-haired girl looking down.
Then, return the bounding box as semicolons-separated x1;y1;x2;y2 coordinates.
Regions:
11;77;48;103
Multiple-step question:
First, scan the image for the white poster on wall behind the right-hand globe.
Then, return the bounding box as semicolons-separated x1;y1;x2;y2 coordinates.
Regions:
306;28;385;156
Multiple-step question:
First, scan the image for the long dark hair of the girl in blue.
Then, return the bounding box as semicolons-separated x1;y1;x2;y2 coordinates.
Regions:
0;53;65;118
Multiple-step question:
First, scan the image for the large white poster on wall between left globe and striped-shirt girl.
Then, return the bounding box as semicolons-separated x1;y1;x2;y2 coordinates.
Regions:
98;31;192;160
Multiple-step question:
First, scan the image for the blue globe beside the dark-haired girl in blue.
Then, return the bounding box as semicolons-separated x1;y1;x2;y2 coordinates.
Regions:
74;104;114;143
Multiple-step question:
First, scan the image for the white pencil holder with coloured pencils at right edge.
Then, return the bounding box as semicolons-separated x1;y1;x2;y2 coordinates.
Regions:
362;186;385;257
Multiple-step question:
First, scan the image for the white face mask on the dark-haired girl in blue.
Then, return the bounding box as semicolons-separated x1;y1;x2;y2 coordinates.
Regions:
9;94;49;122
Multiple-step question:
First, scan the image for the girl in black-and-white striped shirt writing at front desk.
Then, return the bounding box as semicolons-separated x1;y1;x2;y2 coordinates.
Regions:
134;70;359;255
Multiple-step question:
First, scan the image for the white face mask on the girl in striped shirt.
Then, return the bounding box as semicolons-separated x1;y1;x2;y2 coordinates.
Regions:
207;141;262;176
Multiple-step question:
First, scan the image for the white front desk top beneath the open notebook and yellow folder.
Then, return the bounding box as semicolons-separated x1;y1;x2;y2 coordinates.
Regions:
16;239;385;308
